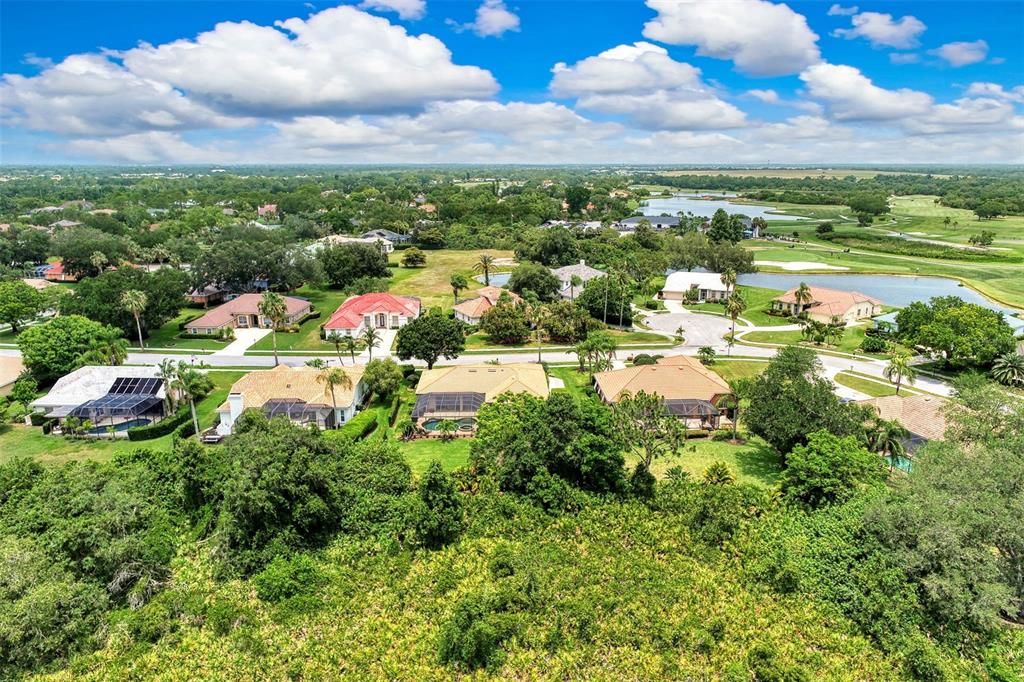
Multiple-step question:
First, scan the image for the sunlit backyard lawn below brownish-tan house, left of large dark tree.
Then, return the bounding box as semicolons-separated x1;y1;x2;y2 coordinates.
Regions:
626;438;782;487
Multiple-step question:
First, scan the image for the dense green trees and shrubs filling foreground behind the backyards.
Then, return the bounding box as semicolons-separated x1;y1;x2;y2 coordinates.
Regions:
0;348;1024;680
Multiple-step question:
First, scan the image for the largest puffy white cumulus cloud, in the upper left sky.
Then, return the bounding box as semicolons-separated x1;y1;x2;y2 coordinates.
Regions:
123;6;498;115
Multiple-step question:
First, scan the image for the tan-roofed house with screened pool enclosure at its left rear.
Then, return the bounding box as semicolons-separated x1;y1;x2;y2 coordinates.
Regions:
413;363;550;435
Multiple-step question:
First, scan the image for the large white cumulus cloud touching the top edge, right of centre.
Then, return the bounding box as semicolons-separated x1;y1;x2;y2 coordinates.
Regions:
643;0;821;76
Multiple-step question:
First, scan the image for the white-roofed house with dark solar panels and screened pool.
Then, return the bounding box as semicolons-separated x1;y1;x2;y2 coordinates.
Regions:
30;365;167;436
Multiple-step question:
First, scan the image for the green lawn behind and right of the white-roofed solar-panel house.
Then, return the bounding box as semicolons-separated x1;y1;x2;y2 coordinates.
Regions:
0;370;245;464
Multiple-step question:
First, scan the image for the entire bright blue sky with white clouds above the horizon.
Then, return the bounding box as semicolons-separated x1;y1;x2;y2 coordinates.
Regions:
0;0;1024;164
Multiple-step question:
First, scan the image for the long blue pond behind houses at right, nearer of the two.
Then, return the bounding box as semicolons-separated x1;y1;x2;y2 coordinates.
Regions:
738;272;1018;315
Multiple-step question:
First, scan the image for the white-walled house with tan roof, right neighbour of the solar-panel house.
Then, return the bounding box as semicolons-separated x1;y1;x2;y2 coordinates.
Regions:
216;365;367;436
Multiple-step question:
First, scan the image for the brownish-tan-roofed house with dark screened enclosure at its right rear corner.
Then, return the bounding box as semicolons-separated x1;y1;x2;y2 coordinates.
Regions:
594;355;732;430
